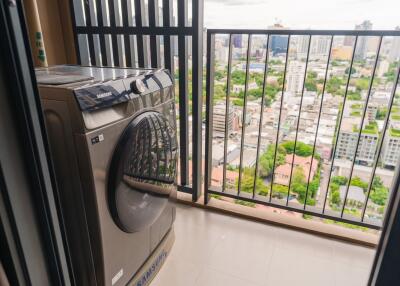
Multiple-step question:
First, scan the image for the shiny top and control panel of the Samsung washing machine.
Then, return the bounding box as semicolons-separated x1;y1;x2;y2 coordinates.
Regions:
36;65;173;111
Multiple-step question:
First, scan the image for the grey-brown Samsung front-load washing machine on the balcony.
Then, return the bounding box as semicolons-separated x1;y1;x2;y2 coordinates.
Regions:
36;65;178;286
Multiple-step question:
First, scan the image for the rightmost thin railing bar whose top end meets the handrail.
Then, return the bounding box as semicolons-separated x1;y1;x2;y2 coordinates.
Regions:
340;36;382;217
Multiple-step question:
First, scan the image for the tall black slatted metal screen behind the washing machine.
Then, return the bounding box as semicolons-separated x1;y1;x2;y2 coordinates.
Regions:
70;0;203;201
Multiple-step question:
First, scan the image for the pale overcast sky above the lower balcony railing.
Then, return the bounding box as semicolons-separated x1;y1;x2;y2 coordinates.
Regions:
204;0;400;30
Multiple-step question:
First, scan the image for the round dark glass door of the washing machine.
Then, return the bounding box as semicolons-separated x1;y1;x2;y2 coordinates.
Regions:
108;111;177;233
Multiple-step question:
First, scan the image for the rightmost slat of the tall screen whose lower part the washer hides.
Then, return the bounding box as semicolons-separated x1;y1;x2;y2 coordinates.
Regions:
163;0;174;75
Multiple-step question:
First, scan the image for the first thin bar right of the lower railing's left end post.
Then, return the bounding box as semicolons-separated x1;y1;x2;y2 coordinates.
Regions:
223;34;233;192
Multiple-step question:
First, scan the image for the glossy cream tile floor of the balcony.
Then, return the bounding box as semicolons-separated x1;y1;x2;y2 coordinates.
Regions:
151;205;374;286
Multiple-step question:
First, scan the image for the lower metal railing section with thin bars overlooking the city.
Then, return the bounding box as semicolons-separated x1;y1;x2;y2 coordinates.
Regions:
204;29;400;229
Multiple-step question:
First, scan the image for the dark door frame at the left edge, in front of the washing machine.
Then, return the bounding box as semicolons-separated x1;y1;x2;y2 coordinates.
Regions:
0;1;73;285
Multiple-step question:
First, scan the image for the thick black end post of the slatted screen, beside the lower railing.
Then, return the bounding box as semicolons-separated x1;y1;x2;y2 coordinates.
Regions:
191;0;204;201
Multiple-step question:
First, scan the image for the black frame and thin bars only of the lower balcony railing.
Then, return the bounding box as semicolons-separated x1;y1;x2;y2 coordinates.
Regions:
204;29;400;229
